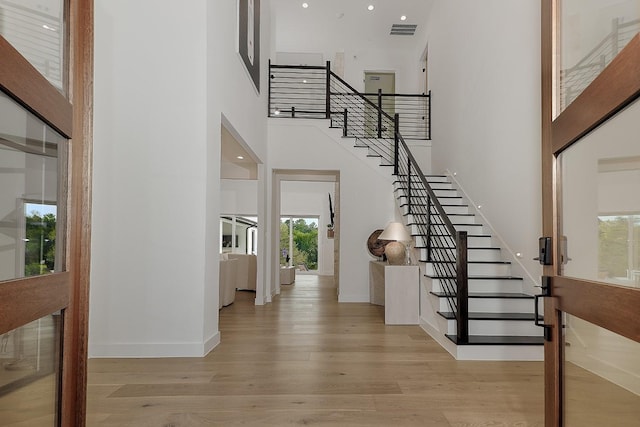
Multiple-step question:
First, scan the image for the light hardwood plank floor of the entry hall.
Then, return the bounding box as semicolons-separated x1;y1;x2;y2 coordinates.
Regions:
87;275;543;427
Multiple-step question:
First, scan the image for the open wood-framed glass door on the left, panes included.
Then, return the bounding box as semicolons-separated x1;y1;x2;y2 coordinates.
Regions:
0;0;93;426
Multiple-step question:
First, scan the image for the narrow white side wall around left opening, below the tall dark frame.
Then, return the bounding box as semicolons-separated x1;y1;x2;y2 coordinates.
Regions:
205;0;271;310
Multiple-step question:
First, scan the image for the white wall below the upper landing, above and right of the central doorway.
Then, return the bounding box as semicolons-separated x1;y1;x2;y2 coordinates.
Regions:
269;119;395;302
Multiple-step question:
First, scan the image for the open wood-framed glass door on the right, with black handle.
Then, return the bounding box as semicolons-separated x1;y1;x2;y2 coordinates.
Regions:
542;0;640;427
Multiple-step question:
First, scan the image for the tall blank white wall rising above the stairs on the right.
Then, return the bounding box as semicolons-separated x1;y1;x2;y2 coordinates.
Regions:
427;0;542;284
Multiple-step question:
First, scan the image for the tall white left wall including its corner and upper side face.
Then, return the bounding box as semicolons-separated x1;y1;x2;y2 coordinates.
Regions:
89;0;270;357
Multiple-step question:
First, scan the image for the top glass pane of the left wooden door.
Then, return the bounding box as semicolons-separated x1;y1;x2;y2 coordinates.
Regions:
0;0;66;93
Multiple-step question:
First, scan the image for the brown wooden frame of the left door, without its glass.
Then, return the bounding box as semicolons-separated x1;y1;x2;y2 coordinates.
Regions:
0;0;93;426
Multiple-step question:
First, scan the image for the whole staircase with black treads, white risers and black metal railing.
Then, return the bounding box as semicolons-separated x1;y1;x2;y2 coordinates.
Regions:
269;63;543;360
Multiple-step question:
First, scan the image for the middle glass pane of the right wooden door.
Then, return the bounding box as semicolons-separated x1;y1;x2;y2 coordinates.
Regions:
559;98;640;287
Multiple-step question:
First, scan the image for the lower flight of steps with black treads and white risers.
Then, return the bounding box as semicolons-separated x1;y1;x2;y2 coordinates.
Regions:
394;176;544;360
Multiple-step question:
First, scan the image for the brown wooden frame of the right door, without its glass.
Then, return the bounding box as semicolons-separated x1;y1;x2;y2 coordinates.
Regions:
541;0;640;427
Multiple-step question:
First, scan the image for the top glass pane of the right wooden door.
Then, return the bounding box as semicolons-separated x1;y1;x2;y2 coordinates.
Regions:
556;0;640;115
